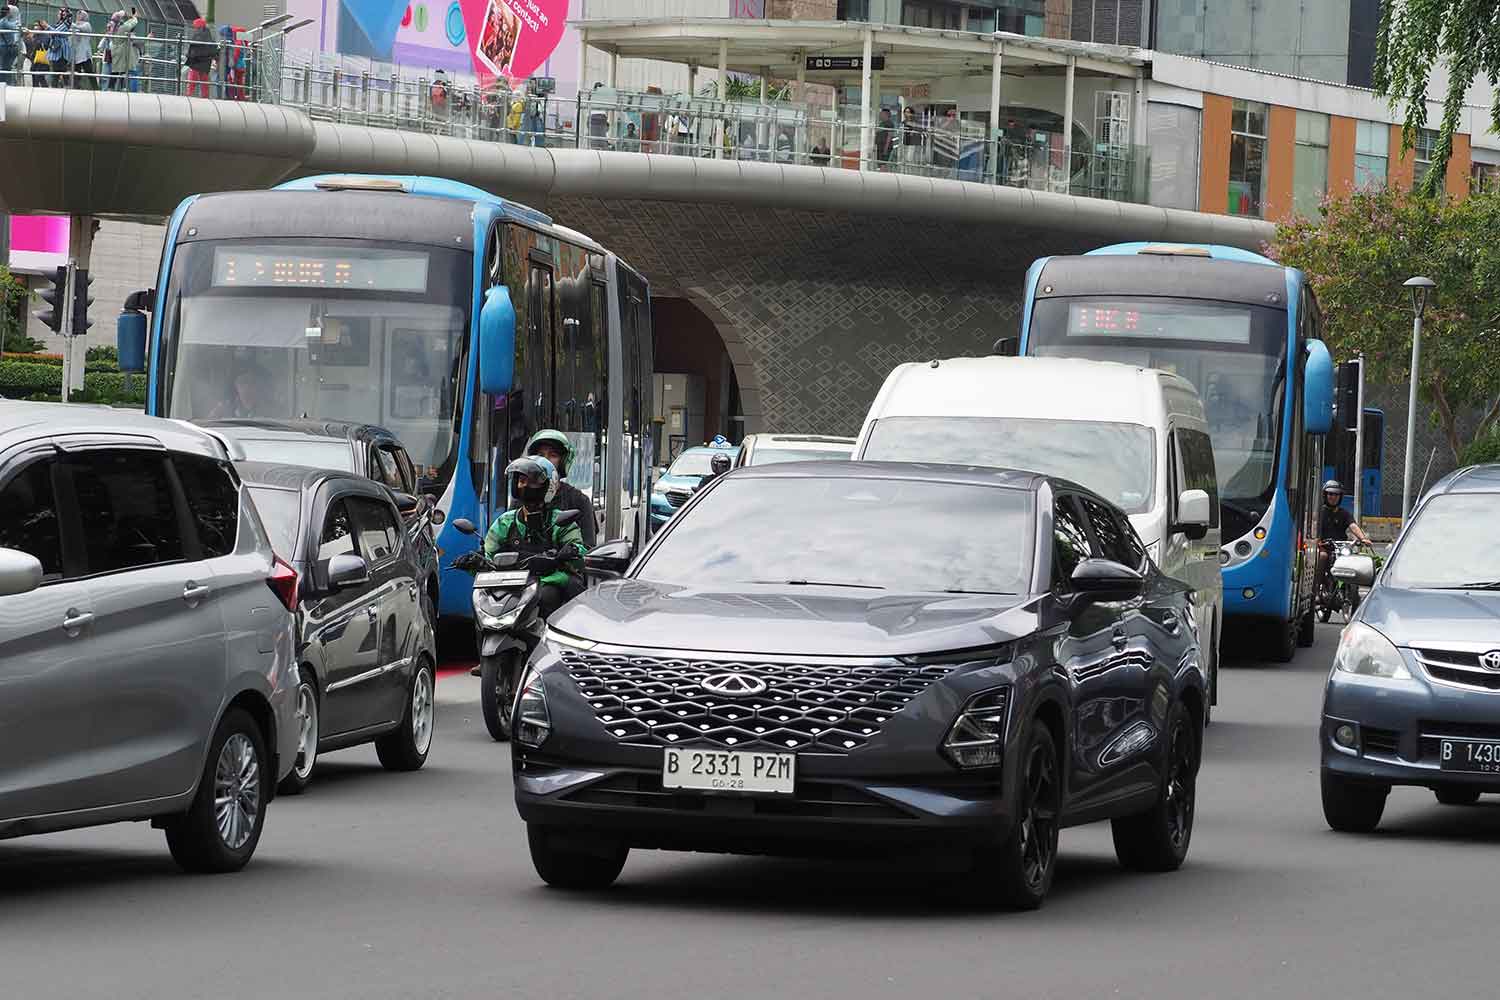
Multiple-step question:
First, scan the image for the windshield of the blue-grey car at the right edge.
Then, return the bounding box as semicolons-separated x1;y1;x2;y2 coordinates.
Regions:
1383;493;1500;589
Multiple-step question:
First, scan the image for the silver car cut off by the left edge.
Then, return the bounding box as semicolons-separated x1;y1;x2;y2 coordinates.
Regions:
0;402;297;871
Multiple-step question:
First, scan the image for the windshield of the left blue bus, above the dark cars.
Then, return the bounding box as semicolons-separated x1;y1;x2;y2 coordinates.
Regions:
161;240;473;483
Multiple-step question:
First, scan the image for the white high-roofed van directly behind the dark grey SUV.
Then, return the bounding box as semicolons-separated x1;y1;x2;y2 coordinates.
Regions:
854;357;1224;710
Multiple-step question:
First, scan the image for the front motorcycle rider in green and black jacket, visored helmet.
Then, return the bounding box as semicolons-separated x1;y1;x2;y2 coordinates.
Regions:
453;456;587;618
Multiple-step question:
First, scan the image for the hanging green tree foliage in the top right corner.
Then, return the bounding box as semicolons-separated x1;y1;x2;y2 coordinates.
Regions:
1374;0;1500;195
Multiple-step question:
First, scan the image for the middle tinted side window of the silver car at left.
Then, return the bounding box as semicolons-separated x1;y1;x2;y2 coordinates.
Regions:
62;448;183;574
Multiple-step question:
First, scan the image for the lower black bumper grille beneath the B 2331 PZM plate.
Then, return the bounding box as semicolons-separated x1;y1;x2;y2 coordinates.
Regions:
563;772;914;820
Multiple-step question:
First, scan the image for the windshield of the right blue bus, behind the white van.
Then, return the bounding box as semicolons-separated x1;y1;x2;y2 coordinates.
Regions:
1026;295;1287;505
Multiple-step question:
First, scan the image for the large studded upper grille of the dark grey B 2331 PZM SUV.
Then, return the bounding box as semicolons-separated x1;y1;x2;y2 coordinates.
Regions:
561;649;954;754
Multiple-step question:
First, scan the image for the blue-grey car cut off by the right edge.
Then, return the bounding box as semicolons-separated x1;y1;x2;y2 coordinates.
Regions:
1320;465;1500;832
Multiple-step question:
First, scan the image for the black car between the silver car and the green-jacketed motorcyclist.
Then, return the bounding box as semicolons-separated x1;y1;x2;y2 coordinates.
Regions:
236;462;438;795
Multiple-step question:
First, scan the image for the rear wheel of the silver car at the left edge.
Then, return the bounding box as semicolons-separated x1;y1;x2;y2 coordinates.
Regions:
164;708;275;873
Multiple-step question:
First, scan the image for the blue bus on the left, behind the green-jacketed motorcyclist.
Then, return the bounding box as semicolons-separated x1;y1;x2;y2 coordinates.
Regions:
120;175;654;616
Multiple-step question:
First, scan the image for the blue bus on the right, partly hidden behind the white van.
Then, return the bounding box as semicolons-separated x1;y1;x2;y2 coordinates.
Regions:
1020;243;1334;661
